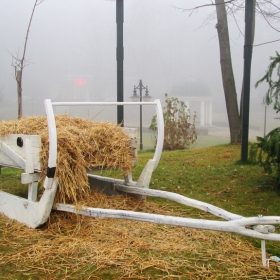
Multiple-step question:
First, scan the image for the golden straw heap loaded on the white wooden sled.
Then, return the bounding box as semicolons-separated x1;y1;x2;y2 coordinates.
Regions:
0;114;133;203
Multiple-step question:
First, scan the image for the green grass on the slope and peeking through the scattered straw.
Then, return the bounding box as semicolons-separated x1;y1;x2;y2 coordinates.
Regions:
0;145;280;279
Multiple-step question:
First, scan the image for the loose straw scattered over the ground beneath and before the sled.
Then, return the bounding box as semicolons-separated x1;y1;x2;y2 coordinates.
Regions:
0;192;280;280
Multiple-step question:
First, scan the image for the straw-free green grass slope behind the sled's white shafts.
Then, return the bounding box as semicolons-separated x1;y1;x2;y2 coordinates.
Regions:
94;145;280;256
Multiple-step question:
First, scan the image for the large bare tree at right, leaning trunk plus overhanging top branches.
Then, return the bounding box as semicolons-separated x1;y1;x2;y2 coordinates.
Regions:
175;0;280;144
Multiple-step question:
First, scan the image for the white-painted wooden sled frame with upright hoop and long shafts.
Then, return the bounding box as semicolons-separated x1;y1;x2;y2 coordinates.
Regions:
0;99;280;266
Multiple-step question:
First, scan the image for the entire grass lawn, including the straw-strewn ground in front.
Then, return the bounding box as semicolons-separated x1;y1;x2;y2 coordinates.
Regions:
0;145;280;279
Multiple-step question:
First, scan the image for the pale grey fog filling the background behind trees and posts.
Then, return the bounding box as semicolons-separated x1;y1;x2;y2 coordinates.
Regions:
0;0;279;138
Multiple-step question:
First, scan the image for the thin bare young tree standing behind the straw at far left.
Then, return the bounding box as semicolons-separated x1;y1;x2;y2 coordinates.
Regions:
12;0;44;119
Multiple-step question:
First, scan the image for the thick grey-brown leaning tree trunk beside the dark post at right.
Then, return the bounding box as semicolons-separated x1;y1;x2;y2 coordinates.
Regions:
215;0;241;144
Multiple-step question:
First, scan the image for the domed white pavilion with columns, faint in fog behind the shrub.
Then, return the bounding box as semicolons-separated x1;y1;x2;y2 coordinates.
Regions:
171;77;213;126
